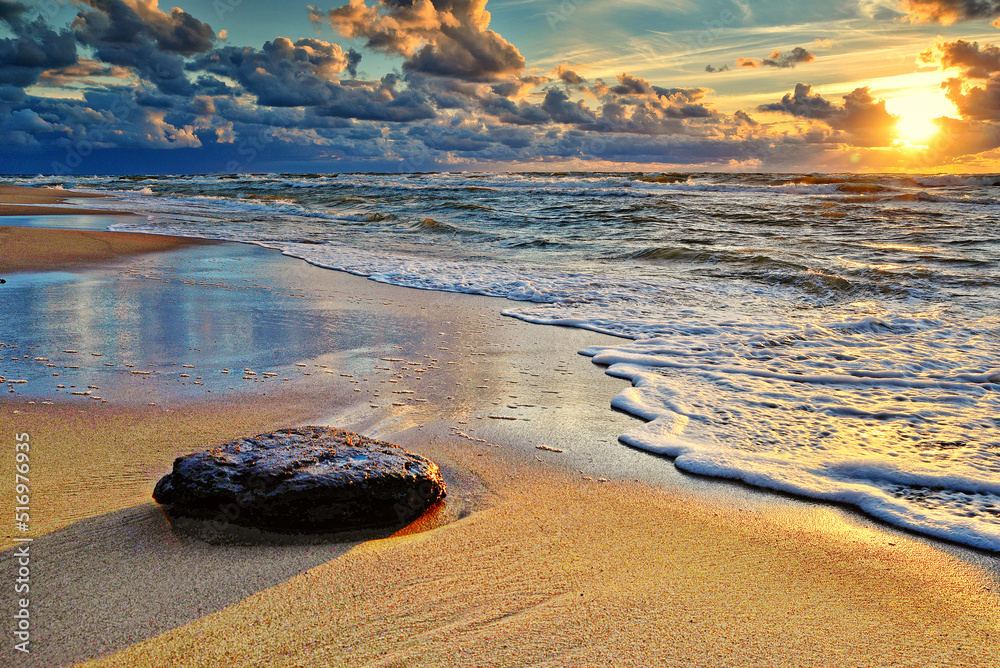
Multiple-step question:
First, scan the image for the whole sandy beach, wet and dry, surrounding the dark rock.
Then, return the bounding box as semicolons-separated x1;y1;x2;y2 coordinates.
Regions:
0;180;1000;666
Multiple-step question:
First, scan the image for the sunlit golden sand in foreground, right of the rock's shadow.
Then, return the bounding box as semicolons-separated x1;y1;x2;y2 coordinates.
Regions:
88;436;1000;666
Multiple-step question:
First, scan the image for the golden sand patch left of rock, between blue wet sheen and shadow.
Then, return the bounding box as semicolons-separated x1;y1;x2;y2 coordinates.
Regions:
0;396;312;549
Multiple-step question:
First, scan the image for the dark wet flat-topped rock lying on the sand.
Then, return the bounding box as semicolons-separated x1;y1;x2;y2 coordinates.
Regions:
153;426;447;533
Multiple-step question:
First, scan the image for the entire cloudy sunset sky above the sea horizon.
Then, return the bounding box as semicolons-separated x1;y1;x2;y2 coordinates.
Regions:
0;0;1000;174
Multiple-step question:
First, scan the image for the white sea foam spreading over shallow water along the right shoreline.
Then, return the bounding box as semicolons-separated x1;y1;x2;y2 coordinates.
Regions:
583;321;1000;550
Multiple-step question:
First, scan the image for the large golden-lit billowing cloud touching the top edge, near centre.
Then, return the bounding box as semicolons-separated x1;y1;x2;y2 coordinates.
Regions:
310;0;525;81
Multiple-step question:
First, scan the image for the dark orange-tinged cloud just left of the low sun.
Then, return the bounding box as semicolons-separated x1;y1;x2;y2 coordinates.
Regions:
758;83;899;146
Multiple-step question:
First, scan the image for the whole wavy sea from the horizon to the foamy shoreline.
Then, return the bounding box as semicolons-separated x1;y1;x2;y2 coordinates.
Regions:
12;172;1000;551
